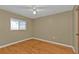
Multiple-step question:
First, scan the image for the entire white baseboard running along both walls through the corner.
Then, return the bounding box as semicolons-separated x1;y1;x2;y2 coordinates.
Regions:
0;37;76;53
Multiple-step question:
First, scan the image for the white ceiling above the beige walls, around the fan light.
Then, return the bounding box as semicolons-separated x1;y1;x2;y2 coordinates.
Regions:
0;5;74;19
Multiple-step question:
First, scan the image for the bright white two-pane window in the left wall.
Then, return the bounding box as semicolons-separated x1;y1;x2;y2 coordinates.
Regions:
10;18;26;30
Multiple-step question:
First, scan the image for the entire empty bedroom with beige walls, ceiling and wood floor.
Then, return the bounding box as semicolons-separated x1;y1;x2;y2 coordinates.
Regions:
0;5;79;54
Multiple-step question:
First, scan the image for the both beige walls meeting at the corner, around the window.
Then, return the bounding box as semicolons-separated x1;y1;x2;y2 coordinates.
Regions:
0;10;74;48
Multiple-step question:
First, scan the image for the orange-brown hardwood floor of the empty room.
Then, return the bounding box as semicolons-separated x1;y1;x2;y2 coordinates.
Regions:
0;39;74;54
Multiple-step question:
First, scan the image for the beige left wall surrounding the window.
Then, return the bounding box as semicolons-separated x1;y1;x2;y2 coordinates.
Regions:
0;10;32;45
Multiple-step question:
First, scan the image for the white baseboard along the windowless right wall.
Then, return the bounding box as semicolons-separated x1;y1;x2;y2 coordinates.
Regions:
33;37;76;53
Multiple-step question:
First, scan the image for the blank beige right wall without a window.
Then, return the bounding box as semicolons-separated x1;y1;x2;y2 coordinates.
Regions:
33;11;73;45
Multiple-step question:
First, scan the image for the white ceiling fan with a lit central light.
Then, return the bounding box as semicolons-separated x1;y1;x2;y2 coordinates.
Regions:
15;5;45;15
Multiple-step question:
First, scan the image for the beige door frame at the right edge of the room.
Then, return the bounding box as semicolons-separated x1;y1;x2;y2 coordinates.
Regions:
72;5;79;53
